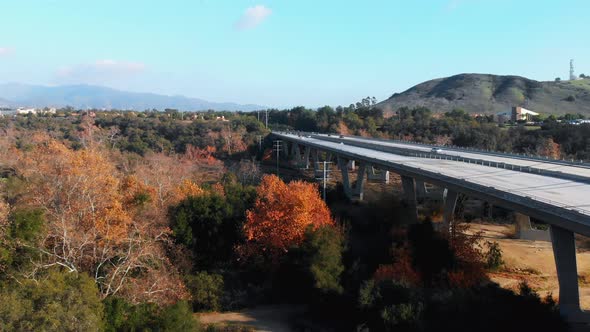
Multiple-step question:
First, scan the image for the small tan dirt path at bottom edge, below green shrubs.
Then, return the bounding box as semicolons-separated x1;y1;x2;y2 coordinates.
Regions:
197;305;305;332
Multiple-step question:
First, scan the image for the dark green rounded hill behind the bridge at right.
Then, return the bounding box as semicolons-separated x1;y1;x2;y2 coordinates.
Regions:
377;74;590;115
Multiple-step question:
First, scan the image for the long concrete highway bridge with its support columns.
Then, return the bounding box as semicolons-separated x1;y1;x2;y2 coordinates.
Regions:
272;132;590;323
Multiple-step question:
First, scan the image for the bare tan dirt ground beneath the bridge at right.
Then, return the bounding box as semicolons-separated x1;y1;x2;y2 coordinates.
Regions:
470;223;590;309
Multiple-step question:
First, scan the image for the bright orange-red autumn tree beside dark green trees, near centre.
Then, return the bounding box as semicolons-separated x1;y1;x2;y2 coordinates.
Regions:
239;175;334;261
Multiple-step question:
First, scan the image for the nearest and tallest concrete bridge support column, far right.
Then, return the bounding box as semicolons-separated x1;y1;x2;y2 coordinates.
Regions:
551;225;590;323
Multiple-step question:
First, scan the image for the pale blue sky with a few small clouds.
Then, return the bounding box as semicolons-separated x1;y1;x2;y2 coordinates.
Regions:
0;0;590;107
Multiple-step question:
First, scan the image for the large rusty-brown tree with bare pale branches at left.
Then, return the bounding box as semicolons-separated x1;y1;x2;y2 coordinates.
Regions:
19;140;185;303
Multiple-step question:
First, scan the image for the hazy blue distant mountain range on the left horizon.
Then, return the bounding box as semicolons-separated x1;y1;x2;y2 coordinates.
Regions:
0;83;267;111
